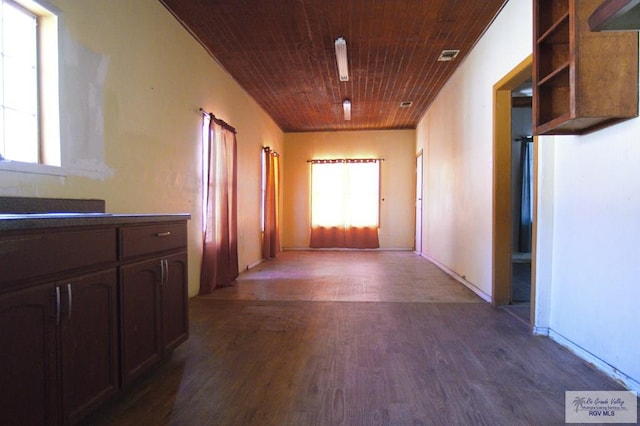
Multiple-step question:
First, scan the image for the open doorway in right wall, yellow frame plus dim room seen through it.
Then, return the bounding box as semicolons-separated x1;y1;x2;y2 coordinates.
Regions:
492;56;536;325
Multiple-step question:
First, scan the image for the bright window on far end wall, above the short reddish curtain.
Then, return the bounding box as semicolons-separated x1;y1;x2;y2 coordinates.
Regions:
311;160;380;228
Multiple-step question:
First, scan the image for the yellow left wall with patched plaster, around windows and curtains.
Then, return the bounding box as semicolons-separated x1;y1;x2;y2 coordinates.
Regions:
0;0;283;295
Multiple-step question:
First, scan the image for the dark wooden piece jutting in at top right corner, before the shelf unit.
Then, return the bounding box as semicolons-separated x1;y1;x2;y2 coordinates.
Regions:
589;0;640;31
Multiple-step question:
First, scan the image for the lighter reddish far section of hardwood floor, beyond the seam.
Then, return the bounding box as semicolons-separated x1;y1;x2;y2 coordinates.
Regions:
207;251;482;303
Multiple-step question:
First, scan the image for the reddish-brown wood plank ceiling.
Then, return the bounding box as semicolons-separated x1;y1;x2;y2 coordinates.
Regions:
160;0;506;132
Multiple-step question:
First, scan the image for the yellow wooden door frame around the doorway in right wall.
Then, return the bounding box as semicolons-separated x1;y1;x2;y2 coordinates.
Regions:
491;55;538;324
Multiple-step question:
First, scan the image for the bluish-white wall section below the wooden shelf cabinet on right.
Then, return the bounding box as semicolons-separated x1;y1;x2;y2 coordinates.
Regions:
549;119;640;390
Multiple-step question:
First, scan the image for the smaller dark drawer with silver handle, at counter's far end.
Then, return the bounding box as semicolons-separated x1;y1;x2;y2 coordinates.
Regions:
120;222;187;259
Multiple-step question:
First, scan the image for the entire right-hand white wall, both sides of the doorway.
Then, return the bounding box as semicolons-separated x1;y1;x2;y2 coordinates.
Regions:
417;0;640;390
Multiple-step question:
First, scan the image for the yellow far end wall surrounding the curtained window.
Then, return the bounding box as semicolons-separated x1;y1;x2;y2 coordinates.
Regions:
282;130;416;249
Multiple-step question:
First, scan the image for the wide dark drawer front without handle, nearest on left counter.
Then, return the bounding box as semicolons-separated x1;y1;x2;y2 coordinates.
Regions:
0;228;117;287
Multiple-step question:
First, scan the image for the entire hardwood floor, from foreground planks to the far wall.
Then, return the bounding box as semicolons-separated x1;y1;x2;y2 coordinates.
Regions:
85;252;622;425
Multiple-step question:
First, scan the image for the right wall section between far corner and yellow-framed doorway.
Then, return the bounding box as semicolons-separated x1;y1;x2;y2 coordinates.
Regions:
417;0;532;299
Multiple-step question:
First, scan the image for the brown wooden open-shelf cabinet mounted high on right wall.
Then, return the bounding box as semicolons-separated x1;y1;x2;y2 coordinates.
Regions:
533;0;640;135
